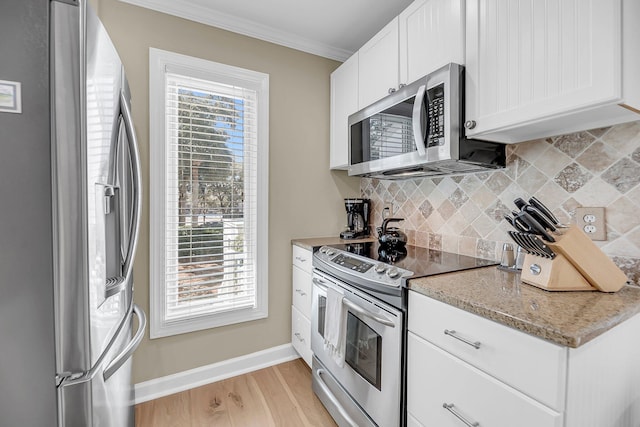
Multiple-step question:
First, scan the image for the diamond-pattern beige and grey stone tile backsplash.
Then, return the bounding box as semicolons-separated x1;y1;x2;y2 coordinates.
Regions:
360;121;640;283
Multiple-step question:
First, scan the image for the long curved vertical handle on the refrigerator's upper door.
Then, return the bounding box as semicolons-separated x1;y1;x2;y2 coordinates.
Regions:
105;91;142;298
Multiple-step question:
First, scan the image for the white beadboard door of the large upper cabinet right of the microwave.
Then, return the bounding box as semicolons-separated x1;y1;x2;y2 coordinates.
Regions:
466;0;621;142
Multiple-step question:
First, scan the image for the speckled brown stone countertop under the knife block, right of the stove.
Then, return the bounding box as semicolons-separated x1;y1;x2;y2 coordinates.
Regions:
409;266;640;348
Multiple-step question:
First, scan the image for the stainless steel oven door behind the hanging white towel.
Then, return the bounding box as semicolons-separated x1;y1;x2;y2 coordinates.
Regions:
311;270;403;426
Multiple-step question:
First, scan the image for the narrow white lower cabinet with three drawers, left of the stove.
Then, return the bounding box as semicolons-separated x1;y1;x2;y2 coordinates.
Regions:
291;245;313;366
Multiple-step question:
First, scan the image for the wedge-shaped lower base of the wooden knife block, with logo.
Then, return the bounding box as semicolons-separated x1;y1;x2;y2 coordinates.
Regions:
520;252;597;291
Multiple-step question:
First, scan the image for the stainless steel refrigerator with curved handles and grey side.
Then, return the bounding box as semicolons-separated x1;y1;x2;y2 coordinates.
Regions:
0;0;146;427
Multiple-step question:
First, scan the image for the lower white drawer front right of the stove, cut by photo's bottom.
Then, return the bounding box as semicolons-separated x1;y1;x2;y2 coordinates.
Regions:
407;332;562;427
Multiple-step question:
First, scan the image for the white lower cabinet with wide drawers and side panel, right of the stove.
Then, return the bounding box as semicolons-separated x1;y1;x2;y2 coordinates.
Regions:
407;291;640;427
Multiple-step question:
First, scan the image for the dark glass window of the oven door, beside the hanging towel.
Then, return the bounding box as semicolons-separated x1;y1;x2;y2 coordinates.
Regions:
344;312;382;390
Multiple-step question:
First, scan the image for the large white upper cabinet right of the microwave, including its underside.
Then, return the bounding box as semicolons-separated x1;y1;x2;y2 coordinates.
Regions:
466;0;640;143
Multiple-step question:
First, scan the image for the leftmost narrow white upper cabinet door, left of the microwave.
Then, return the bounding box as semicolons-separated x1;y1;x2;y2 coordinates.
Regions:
329;52;358;169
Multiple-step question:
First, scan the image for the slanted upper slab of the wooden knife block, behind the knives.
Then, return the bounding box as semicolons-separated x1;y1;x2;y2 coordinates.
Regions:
546;225;628;292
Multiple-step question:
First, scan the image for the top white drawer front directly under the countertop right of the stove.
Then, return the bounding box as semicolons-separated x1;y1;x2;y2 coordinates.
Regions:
409;291;567;411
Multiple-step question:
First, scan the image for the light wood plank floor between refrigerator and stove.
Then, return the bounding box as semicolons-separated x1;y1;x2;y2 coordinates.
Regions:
136;359;336;427
